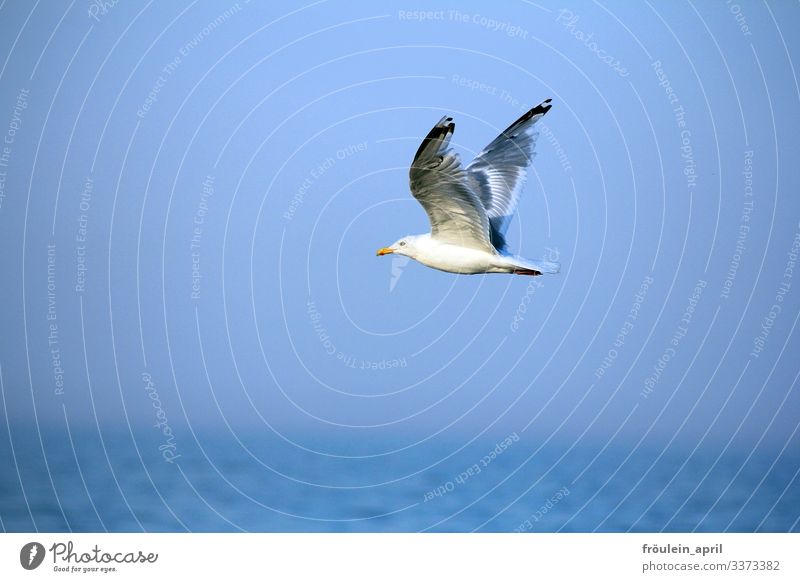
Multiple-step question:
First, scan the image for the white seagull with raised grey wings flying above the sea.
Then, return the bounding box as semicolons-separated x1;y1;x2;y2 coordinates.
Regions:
376;99;559;276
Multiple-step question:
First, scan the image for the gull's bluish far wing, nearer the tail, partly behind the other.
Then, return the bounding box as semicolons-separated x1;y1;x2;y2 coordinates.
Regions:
466;99;551;250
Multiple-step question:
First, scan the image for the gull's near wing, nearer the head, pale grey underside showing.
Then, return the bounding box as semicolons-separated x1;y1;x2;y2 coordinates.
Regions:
409;116;495;253
